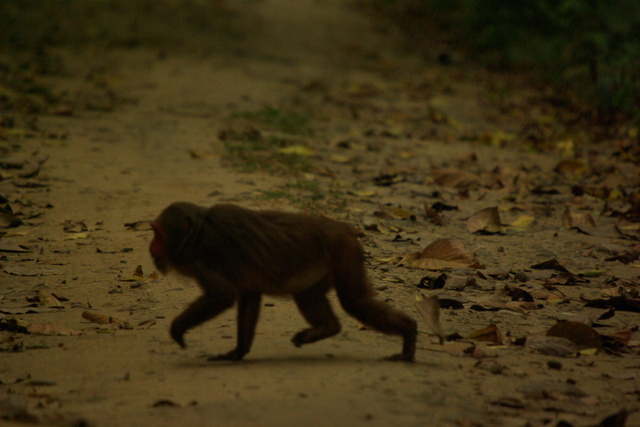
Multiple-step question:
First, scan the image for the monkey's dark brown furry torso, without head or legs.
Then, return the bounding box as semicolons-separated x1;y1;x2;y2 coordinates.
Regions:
198;204;362;294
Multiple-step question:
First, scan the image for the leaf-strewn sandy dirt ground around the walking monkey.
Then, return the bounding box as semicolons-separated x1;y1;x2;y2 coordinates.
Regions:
0;0;640;426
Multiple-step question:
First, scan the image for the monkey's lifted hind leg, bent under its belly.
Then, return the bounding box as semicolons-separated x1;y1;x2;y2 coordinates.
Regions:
291;285;340;347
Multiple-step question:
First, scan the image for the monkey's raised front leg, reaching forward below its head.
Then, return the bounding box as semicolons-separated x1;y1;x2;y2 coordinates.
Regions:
170;292;235;348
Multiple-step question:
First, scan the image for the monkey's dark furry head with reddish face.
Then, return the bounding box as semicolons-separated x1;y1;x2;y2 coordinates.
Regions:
149;202;203;274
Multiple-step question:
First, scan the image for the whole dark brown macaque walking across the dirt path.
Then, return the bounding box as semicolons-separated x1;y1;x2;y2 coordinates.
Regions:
149;202;417;361
